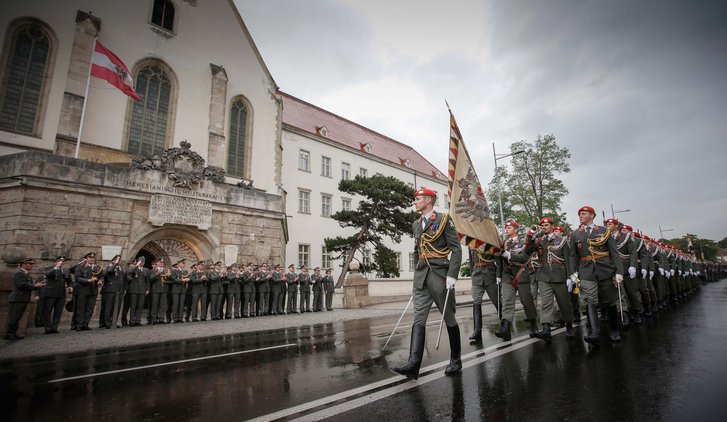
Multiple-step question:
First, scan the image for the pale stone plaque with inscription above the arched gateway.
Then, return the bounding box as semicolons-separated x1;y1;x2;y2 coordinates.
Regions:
149;195;212;230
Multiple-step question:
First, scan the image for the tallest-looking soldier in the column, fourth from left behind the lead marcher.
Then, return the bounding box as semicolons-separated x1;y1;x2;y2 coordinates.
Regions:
568;206;624;346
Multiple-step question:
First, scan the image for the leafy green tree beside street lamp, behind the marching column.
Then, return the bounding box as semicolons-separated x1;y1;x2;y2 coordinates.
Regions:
488;135;570;231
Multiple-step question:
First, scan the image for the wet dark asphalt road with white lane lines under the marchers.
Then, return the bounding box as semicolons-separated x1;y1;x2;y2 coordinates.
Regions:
0;280;727;422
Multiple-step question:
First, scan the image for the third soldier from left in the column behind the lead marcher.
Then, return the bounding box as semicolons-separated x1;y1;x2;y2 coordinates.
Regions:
529;217;575;341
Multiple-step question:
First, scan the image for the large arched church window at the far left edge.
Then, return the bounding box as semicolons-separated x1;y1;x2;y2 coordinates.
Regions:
0;22;52;135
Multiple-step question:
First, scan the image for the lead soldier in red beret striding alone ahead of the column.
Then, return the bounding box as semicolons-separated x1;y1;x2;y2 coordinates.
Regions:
392;189;462;379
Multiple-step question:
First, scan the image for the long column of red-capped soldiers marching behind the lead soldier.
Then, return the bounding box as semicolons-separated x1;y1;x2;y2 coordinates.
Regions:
470;206;727;346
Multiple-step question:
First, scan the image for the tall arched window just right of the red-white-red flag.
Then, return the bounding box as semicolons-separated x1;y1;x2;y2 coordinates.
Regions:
127;62;174;157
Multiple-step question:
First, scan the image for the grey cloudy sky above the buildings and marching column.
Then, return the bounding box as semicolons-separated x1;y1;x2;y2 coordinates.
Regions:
235;0;727;240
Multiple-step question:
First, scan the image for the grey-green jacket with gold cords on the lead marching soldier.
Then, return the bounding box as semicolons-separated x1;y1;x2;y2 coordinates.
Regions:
412;211;462;289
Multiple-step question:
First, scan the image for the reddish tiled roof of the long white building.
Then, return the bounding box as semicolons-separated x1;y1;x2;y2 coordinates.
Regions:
278;91;447;182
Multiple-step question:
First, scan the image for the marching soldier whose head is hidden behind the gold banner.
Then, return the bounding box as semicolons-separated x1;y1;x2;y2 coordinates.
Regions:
469;244;502;343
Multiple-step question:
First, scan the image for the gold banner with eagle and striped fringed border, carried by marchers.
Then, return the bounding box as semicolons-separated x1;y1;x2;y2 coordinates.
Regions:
447;106;501;252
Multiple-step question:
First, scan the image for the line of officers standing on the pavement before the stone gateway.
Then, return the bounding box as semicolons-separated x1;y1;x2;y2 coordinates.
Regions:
5;252;335;340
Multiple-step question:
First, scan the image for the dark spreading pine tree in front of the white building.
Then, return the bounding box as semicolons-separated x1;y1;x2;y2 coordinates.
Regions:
324;175;418;287
